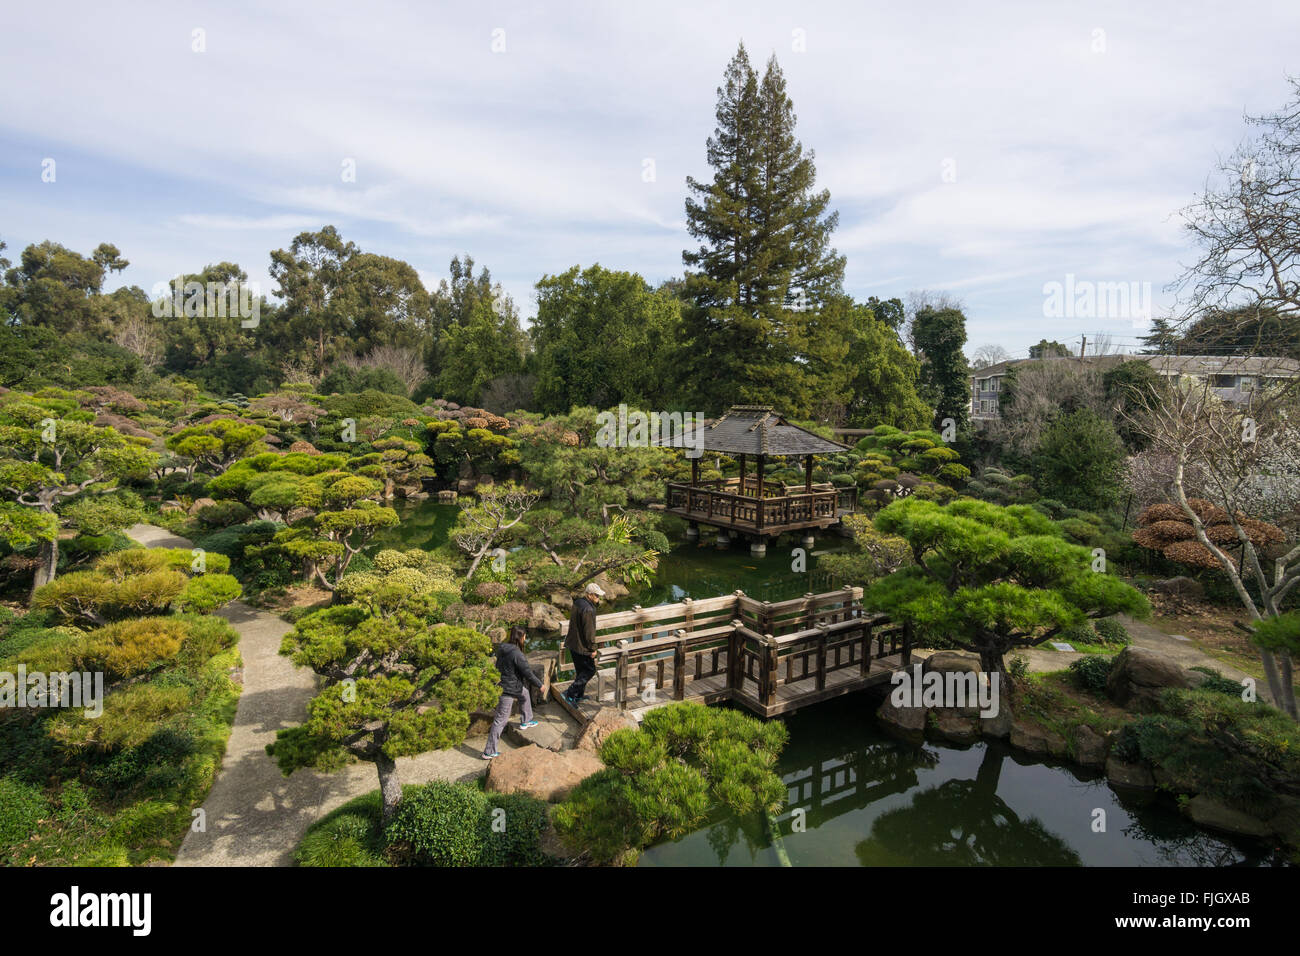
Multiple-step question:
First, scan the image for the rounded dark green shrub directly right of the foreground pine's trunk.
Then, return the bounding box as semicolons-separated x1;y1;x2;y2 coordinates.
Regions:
385;780;489;866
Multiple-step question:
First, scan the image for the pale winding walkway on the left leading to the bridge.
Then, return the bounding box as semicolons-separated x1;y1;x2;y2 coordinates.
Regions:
126;524;525;866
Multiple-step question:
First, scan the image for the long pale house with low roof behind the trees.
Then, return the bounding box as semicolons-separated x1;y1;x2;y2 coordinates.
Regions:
971;355;1300;424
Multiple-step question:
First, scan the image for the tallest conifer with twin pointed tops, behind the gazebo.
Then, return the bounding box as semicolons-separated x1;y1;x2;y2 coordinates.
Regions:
683;44;850;415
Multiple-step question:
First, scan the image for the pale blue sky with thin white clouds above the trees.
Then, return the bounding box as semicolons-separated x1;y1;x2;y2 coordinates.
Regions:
0;0;1300;356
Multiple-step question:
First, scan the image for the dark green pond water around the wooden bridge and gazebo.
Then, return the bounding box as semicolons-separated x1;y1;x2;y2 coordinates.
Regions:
376;502;1282;866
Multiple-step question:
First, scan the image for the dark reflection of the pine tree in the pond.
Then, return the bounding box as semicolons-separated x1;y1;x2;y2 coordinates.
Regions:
855;747;1082;866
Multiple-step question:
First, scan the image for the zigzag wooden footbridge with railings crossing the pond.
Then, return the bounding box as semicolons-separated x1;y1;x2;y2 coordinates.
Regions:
553;587;911;717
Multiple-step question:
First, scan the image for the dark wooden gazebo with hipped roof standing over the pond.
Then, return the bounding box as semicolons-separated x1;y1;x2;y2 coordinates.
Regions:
660;405;858;554
